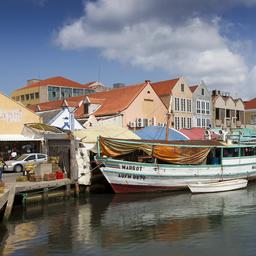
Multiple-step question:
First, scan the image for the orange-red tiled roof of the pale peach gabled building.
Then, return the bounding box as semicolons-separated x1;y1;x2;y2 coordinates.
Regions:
87;82;148;116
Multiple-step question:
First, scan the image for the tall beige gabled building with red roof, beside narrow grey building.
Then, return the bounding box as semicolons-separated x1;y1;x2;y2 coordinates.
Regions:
152;77;193;130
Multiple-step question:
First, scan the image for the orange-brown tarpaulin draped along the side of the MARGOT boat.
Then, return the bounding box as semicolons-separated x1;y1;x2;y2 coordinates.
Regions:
99;137;210;164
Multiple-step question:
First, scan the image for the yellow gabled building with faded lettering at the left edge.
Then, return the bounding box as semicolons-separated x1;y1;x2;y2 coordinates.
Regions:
0;93;41;159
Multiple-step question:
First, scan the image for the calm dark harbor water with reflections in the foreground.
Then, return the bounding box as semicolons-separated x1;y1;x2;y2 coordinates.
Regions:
0;183;256;256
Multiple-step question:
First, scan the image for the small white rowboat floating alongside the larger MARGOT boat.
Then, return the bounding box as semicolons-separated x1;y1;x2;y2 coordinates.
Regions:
188;179;248;193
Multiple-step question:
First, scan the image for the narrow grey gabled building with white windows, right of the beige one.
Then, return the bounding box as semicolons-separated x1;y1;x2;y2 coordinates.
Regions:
190;81;212;128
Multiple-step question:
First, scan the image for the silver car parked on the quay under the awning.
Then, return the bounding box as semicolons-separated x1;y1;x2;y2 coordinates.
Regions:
4;153;48;172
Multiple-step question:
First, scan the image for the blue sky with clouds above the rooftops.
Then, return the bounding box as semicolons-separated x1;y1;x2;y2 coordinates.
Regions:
0;0;256;99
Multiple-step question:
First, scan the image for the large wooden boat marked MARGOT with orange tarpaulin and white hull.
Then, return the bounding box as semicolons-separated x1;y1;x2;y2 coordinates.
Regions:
96;137;256;193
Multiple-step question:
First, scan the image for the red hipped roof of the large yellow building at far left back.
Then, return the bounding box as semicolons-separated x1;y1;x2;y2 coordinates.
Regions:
16;76;90;91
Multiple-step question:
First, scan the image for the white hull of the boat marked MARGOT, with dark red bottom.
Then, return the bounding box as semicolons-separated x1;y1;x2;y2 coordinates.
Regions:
100;157;256;193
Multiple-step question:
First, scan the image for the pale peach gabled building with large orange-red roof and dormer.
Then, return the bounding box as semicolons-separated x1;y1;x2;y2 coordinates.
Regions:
80;81;167;129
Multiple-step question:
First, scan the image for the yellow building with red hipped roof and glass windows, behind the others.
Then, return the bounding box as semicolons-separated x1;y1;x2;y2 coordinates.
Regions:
11;77;98;105
